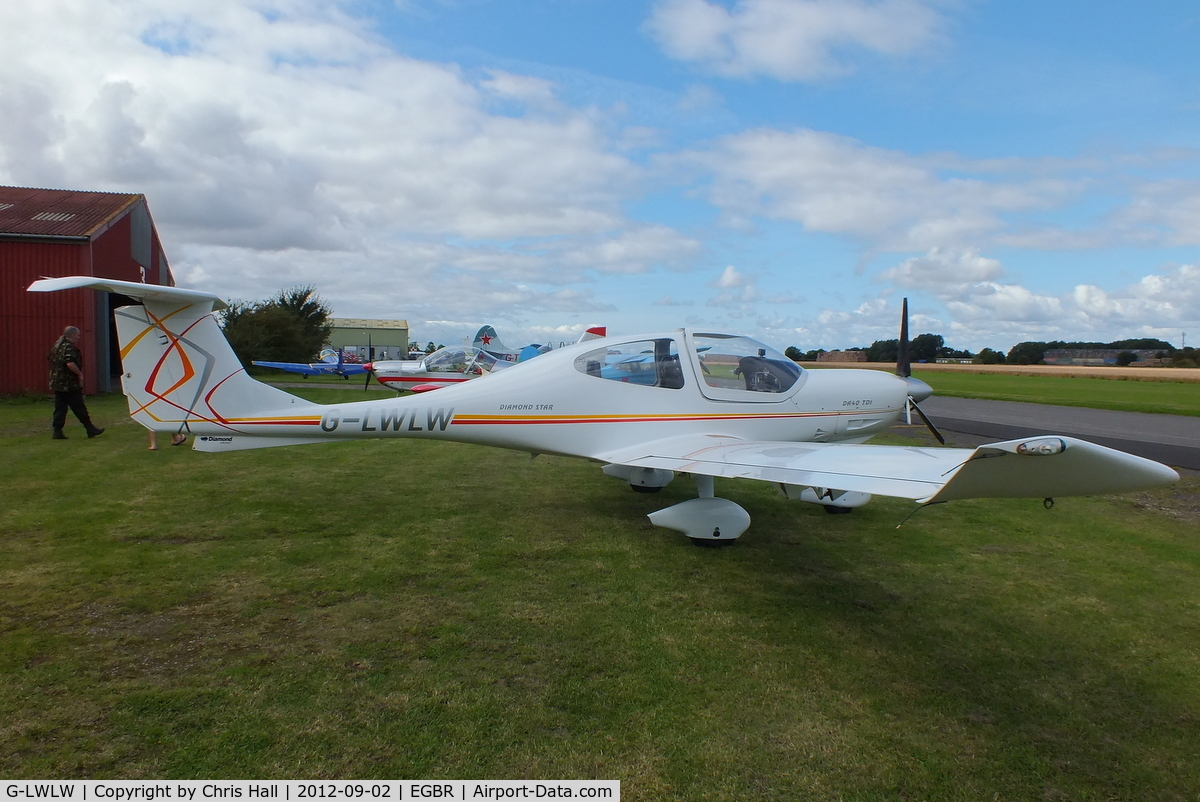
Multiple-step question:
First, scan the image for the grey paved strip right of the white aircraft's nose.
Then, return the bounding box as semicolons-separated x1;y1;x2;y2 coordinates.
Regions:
913;396;1200;469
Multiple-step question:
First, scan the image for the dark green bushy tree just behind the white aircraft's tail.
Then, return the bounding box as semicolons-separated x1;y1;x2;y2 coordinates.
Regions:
221;287;331;365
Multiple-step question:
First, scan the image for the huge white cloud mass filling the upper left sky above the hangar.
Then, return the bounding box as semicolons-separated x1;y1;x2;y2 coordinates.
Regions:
0;0;676;328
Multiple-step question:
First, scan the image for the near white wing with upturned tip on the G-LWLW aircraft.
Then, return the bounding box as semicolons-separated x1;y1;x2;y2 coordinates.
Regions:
596;435;1178;504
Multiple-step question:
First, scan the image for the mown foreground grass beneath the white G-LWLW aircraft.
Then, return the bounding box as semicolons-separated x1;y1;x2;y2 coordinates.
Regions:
0;389;1200;800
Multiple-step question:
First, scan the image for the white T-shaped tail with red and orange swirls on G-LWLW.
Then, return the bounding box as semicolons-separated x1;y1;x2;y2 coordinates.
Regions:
29;276;314;434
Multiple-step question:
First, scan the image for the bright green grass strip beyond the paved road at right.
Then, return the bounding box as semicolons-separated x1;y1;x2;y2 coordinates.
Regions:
913;370;1200;415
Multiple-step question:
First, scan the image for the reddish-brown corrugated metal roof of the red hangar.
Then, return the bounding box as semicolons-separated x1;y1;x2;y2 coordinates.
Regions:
0;186;144;238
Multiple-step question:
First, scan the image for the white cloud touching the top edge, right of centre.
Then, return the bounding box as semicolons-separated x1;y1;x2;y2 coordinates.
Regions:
646;0;943;80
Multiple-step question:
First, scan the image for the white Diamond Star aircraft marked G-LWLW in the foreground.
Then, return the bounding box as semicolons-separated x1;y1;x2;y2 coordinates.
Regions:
29;276;1178;544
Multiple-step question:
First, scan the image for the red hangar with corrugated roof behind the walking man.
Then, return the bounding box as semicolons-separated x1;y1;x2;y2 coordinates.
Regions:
0;186;175;394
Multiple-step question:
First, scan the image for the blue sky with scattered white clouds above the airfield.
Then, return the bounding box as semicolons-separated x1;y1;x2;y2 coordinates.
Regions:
0;0;1200;352
